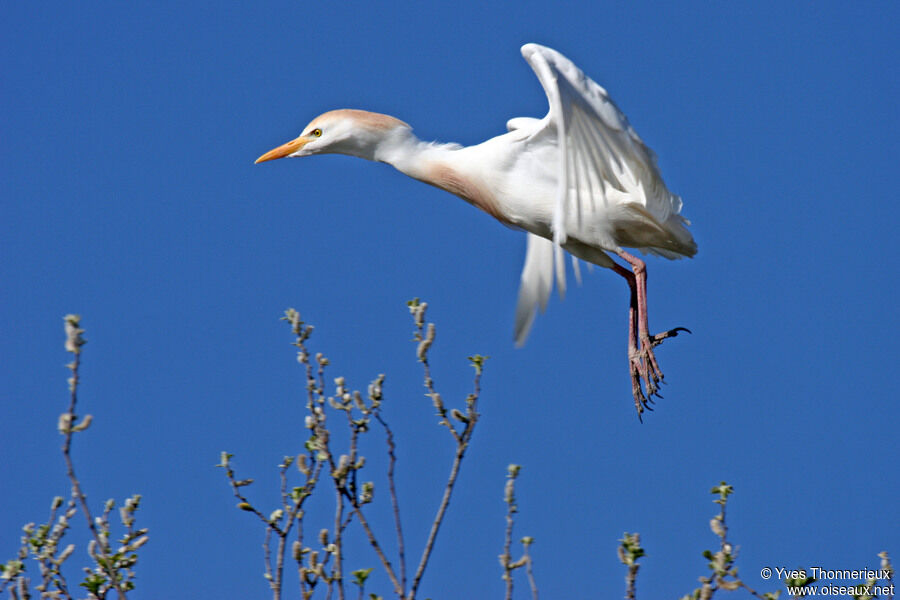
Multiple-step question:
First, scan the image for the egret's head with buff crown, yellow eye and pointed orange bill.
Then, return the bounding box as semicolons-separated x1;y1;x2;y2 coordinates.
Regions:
256;108;410;164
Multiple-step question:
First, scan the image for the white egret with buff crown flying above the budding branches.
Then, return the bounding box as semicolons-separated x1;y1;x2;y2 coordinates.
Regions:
256;44;697;417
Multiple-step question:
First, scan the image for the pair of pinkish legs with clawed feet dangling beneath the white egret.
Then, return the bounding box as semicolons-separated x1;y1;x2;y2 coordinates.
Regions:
613;250;689;418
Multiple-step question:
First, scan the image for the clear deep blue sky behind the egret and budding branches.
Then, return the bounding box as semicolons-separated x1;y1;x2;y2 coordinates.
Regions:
0;2;900;599
